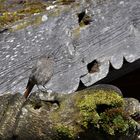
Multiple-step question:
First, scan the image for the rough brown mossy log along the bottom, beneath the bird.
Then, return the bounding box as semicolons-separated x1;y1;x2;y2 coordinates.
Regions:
0;85;140;140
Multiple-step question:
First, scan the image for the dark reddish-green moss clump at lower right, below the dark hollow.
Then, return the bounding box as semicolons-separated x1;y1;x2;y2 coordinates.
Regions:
100;108;136;135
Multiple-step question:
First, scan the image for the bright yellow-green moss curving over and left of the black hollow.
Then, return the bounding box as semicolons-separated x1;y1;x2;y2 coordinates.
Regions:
77;90;124;128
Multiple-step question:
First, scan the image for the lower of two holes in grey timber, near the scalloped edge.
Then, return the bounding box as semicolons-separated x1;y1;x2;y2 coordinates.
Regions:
87;60;100;73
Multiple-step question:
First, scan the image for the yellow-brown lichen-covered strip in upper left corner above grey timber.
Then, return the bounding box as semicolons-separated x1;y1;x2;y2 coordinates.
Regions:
0;0;50;29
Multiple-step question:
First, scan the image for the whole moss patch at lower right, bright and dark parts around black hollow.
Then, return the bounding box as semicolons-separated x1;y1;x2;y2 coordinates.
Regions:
77;90;136;135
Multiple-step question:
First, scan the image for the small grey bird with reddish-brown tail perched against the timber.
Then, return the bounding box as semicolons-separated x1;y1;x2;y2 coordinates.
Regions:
24;56;54;98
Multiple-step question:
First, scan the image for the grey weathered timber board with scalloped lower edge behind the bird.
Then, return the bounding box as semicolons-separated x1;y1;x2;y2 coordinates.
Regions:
0;0;140;93
